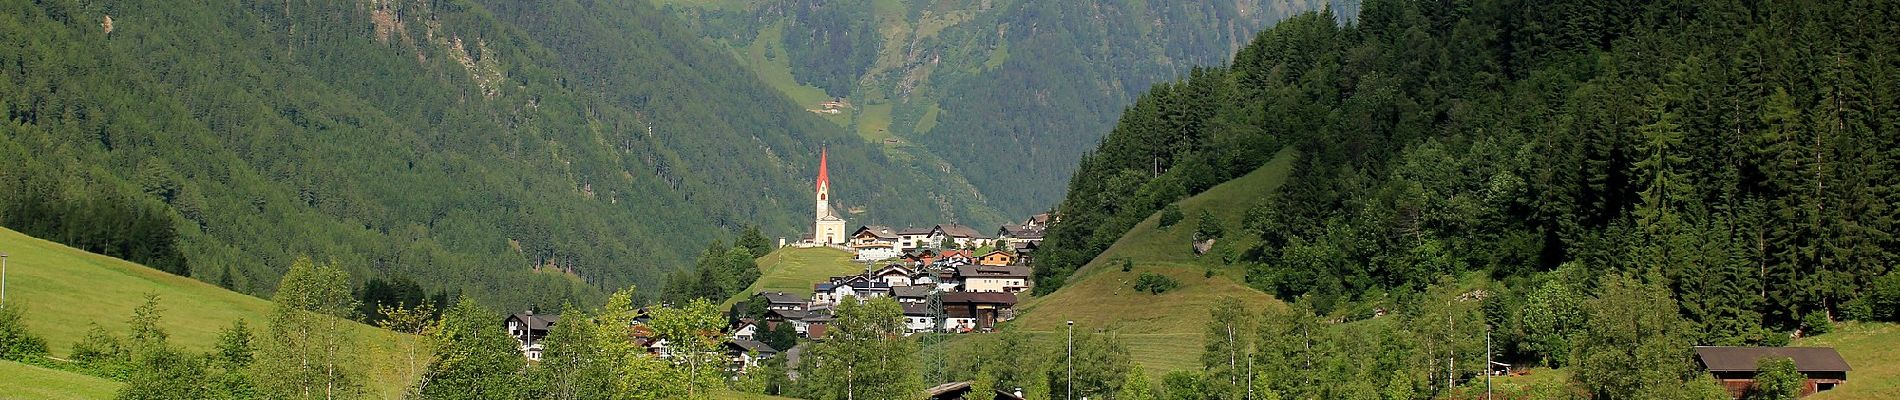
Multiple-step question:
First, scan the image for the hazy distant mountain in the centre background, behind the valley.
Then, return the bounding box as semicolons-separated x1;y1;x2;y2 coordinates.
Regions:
654;0;1357;216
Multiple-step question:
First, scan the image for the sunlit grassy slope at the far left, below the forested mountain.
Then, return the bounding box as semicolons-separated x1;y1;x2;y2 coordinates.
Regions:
0;229;416;398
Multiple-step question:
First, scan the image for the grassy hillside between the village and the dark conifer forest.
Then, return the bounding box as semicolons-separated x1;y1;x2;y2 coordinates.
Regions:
1013;152;1294;375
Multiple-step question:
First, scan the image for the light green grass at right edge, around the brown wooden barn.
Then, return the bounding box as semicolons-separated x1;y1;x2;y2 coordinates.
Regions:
1794;322;1900;400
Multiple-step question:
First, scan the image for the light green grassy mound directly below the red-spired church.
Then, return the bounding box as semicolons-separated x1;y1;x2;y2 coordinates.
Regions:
722;246;865;307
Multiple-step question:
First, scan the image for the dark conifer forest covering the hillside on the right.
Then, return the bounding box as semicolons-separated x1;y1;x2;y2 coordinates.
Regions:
1036;0;1900;384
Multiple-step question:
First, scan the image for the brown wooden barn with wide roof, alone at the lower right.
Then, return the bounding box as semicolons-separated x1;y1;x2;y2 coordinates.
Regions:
1695;347;1849;398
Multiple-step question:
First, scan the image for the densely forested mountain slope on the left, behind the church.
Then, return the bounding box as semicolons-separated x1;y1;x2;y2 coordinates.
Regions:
0;0;994;307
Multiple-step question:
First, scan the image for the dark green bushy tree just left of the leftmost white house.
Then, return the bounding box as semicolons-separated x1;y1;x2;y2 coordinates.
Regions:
418;300;526;400
